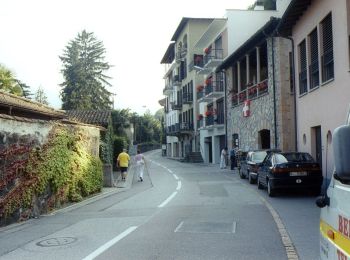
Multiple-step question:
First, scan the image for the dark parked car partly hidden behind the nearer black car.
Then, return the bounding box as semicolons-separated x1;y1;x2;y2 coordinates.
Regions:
239;150;268;184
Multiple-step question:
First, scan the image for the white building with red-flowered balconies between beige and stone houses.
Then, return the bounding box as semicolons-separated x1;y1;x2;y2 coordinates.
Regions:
194;0;289;163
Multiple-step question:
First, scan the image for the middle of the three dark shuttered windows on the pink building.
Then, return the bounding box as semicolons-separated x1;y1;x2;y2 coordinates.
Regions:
309;28;320;89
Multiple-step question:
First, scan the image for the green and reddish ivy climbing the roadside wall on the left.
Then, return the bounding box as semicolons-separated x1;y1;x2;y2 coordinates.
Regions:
0;125;103;218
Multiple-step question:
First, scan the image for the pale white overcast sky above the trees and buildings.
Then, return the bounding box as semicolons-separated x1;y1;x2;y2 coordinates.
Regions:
0;0;255;114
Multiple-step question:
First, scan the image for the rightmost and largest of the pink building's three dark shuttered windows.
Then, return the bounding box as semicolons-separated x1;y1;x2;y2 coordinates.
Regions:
321;14;334;82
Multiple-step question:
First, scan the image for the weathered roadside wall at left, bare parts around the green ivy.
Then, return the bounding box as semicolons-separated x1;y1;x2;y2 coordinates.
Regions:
0;115;100;226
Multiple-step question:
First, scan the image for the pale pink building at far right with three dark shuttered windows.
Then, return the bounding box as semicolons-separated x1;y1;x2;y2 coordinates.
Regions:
278;0;350;178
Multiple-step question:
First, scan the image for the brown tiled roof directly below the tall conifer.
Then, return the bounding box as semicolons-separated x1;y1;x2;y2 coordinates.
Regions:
66;110;111;126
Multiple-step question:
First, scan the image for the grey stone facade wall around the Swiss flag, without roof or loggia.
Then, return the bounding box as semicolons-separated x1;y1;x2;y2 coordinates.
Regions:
226;35;294;150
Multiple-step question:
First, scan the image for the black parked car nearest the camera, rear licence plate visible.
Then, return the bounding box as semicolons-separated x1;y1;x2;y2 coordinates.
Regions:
257;152;323;197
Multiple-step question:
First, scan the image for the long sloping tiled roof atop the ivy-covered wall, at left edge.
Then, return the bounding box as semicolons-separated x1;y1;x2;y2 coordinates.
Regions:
0;90;65;118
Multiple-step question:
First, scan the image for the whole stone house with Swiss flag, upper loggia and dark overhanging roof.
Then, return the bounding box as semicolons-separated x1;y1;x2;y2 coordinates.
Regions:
218;17;295;151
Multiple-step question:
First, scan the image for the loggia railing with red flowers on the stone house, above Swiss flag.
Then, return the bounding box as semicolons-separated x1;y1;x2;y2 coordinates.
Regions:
231;79;269;107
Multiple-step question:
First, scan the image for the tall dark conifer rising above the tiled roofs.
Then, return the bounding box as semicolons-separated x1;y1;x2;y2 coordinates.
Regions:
60;30;112;110
